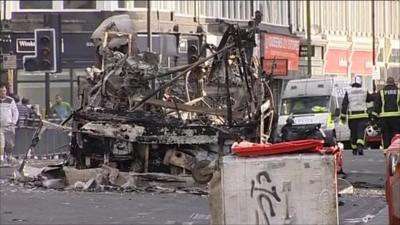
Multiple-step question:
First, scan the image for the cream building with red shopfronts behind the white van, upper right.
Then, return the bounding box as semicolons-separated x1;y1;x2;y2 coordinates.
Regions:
290;0;400;87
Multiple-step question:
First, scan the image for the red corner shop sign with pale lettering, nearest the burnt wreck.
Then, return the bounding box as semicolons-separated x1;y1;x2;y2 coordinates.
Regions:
264;33;300;70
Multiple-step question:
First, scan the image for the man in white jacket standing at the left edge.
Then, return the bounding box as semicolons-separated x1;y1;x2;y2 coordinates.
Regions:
0;84;18;163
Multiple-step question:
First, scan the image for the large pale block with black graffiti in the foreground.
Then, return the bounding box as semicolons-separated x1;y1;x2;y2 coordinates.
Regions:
219;154;339;225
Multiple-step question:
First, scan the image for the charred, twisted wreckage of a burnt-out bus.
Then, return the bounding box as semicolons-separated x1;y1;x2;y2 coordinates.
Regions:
69;16;273;183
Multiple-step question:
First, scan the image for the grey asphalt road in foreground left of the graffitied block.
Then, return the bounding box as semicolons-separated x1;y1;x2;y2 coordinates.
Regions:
0;183;209;225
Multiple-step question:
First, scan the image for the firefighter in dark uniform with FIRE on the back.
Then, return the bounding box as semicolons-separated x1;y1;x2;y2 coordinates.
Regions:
372;77;400;149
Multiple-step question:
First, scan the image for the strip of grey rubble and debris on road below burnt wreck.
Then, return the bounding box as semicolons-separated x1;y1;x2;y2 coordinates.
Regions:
10;164;208;196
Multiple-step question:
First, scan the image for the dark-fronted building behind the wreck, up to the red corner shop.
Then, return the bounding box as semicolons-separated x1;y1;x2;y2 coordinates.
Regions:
0;0;299;115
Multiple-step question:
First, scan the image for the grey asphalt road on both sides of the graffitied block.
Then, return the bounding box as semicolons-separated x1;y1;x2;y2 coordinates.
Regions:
0;150;387;225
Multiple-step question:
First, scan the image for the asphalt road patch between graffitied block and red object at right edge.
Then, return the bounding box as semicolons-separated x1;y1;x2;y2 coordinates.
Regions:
339;150;388;224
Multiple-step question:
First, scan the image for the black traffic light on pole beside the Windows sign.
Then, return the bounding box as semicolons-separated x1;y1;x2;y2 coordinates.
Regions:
23;28;57;73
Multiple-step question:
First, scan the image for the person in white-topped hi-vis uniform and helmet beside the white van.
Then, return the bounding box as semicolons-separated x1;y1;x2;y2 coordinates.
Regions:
340;76;374;155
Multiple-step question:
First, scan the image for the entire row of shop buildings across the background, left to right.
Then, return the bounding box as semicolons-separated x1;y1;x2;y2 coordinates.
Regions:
0;0;400;116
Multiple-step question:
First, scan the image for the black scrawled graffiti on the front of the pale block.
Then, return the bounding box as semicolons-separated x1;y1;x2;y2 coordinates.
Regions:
250;171;281;225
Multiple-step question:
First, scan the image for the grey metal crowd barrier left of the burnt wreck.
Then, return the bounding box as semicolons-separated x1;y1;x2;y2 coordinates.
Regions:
13;119;70;159
